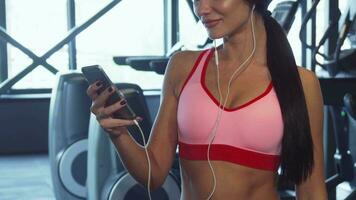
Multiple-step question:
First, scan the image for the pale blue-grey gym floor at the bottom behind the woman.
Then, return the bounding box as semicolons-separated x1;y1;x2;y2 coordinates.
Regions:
0;154;350;200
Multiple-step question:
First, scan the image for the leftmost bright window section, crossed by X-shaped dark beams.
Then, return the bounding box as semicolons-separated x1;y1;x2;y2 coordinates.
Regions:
5;0;68;89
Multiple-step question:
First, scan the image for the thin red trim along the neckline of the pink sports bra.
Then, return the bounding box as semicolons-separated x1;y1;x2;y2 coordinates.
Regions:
200;50;273;112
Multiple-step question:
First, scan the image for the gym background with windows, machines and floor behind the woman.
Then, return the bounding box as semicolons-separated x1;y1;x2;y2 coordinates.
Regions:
0;0;356;200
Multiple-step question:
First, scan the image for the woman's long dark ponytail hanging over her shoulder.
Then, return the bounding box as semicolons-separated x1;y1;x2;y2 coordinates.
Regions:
252;0;314;184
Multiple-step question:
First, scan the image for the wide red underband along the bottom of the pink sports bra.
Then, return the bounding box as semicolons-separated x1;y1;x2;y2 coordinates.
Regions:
179;142;280;171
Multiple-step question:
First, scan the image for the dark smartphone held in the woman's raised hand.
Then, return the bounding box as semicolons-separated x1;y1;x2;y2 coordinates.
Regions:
82;65;136;120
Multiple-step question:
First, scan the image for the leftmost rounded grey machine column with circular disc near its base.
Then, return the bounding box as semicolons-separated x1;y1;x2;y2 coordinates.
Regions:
48;72;91;200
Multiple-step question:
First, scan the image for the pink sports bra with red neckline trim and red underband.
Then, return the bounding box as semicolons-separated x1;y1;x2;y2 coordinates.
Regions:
177;49;283;171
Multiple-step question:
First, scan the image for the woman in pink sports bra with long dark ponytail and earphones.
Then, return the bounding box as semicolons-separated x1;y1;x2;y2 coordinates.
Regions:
87;0;327;200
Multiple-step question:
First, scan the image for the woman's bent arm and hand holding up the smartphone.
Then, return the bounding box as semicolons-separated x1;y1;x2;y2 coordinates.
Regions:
92;50;188;189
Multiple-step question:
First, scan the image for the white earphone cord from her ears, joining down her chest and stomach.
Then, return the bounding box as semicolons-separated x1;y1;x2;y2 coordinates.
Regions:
207;5;256;200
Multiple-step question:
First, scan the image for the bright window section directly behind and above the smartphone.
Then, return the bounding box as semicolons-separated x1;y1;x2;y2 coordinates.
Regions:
76;0;164;89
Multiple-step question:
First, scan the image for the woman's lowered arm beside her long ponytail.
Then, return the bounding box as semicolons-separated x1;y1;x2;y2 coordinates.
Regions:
296;67;327;200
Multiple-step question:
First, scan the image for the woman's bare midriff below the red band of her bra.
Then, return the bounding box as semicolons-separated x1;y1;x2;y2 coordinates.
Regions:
180;159;279;200
